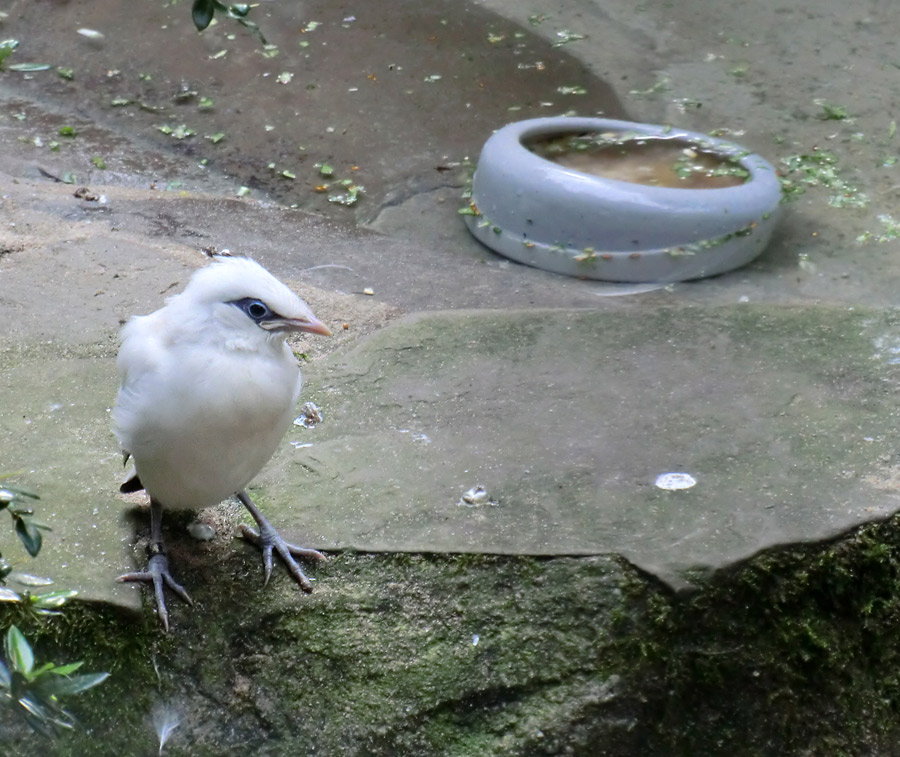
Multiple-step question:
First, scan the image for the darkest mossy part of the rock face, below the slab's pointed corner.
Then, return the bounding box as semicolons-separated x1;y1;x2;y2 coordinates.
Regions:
623;519;900;755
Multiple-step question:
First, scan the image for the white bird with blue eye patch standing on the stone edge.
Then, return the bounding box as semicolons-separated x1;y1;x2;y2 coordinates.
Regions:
113;257;331;630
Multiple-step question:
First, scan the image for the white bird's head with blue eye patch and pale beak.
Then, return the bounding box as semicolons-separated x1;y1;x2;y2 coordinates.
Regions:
178;257;331;336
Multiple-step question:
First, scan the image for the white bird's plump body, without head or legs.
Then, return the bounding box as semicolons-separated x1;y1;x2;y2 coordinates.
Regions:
114;310;301;508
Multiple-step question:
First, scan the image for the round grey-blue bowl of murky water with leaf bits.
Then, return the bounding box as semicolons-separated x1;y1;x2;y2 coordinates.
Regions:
462;117;781;283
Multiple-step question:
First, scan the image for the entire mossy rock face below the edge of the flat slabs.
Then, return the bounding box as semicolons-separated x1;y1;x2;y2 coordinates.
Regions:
5;519;900;757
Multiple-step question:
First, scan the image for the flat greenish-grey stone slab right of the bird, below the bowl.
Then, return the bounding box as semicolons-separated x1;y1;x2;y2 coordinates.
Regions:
258;305;900;587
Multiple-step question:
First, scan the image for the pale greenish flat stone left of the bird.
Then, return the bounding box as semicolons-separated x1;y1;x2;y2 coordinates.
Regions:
0;352;140;609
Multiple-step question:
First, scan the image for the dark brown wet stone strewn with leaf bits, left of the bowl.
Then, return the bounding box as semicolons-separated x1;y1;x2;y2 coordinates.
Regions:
3;0;624;218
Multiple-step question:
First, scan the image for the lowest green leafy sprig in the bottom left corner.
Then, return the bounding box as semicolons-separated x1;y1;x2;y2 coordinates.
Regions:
0;626;109;736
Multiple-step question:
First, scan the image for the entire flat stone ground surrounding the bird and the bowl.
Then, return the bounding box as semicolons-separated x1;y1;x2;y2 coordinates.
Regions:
0;0;900;752
